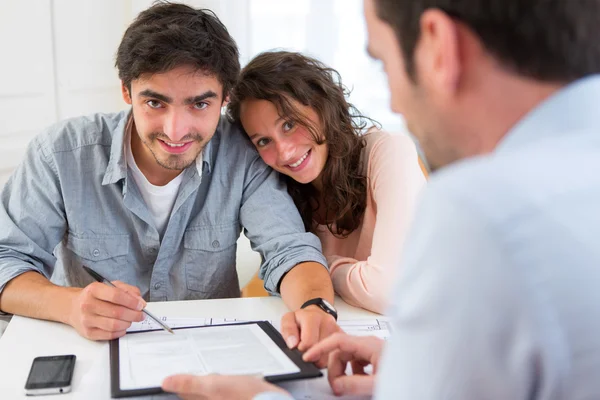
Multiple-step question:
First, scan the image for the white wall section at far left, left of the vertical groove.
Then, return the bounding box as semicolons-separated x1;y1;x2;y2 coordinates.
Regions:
0;0;57;185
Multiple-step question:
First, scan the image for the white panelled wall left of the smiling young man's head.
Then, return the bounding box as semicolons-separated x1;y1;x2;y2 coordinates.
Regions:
0;0;132;185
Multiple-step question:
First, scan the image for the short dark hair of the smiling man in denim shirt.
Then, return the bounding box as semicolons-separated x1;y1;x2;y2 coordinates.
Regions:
115;2;240;96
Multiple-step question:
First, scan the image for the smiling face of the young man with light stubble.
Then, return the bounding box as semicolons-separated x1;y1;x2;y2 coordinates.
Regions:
123;66;223;181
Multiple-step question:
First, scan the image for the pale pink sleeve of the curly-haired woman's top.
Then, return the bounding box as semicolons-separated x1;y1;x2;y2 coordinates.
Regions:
328;135;425;313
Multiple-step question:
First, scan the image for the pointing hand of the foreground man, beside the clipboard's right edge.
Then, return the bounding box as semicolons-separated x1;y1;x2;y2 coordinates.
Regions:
303;333;384;396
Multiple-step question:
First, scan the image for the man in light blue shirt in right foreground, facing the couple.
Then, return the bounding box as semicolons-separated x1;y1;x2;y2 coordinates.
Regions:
164;0;600;400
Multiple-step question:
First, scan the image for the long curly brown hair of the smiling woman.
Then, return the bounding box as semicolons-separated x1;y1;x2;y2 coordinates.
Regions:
227;51;379;237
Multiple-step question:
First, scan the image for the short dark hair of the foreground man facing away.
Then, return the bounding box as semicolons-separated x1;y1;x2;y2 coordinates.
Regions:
373;0;600;82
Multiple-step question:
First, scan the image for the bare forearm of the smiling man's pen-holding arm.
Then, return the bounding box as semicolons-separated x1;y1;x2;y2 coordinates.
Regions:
0;271;81;323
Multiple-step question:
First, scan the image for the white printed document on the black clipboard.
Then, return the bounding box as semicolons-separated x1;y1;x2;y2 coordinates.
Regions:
119;324;300;390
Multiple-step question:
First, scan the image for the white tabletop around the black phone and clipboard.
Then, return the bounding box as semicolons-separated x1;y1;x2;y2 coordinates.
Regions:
0;297;376;400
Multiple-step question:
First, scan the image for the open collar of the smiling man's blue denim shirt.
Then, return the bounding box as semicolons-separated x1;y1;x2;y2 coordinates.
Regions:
102;109;216;185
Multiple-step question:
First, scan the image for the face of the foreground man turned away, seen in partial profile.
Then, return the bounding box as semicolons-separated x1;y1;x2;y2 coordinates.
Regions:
364;0;456;170
